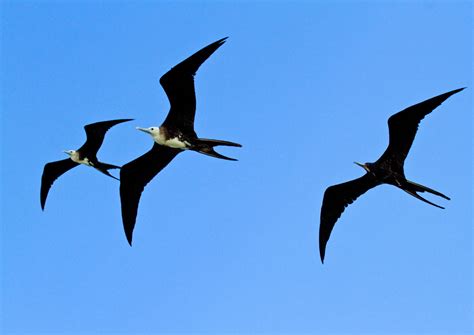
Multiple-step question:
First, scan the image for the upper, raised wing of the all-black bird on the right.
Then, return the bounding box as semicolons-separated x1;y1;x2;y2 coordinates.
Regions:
377;88;464;164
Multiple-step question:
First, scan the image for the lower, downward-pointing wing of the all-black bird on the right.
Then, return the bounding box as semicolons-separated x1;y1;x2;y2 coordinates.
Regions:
319;173;379;263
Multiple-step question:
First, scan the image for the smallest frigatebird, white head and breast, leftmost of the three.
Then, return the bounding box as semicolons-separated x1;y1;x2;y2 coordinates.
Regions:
40;119;133;210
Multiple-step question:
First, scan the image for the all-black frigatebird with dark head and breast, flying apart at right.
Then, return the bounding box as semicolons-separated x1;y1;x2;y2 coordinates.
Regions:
319;88;464;263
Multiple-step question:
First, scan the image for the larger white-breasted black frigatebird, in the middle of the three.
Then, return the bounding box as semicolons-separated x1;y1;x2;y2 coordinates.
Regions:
120;37;241;245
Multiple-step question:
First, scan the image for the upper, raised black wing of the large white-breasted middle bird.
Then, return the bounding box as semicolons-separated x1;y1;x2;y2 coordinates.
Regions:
160;37;227;133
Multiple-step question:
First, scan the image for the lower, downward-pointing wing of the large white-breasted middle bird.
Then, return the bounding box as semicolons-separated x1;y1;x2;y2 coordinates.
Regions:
120;143;181;245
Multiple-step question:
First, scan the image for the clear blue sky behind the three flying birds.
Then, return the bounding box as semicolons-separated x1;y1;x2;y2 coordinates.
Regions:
0;1;473;334
